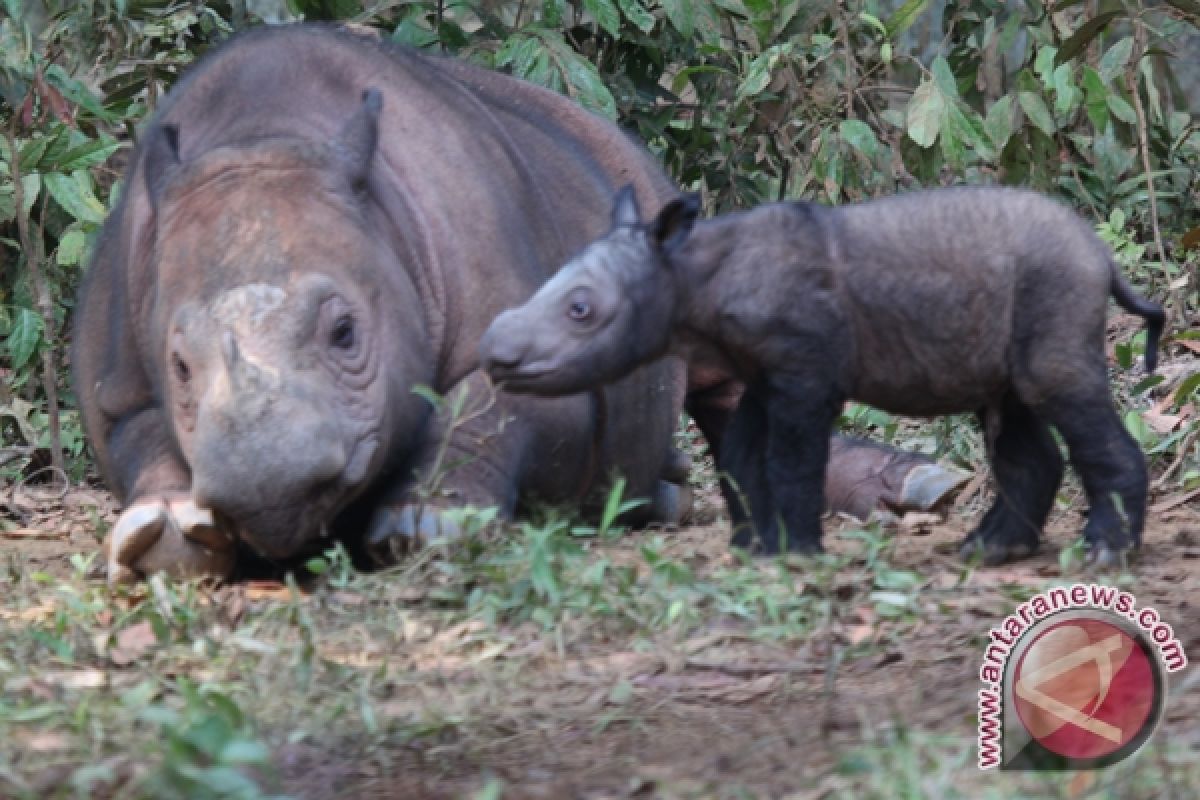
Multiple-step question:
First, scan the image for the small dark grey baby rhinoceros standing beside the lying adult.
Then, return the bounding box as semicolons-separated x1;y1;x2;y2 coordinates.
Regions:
481;188;1164;564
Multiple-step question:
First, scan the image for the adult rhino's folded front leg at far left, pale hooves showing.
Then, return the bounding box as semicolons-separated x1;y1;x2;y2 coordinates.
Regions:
101;409;236;585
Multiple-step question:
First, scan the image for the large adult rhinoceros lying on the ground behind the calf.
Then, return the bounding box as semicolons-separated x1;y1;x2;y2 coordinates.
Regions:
74;26;955;581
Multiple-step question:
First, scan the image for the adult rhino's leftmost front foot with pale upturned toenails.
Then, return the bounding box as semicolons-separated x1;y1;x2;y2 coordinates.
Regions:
103;497;236;585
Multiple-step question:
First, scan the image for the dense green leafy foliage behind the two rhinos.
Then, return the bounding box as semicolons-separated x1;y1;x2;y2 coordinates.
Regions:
0;0;1200;482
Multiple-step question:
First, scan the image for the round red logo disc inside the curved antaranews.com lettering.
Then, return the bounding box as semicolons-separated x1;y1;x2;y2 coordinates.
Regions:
1013;619;1157;759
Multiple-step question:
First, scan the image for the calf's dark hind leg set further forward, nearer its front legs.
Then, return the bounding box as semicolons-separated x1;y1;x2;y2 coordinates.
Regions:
960;395;1062;566
